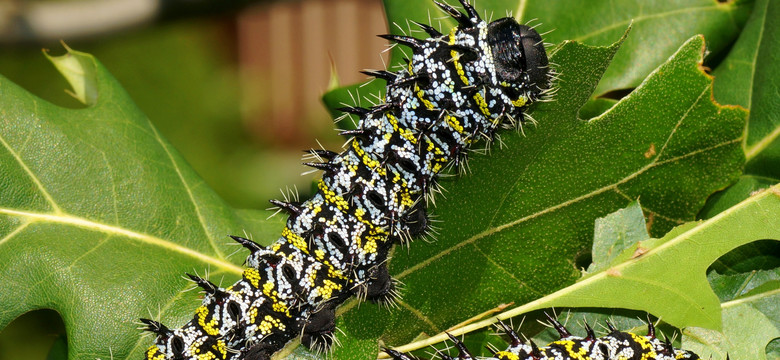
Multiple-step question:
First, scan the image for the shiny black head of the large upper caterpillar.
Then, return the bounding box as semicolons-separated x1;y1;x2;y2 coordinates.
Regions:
487;18;550;102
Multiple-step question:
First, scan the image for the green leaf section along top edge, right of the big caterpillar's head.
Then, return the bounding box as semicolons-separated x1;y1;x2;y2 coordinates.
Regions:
500;0;752;96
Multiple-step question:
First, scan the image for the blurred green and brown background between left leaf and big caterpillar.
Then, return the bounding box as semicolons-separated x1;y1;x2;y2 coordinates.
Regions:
0;0;387;209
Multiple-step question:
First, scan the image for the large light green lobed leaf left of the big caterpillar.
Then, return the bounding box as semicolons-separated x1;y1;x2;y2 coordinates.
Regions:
0;50;282;360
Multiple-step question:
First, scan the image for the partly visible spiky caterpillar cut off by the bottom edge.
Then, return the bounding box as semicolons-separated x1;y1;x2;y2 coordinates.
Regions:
385;314;699;360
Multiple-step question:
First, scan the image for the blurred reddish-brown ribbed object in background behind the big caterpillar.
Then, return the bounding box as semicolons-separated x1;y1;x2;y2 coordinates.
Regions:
236;0;387;147
